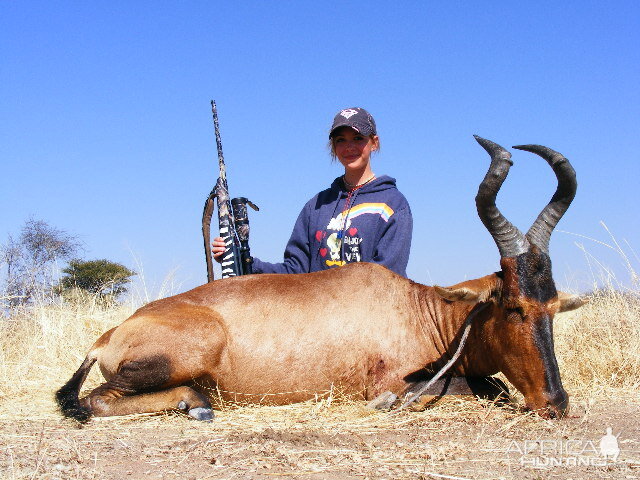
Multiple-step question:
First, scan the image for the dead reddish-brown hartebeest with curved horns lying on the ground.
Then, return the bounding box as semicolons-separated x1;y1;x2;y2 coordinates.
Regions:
57;137;582;421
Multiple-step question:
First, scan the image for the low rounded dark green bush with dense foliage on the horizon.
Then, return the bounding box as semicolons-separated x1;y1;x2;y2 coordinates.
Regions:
60;259;136;298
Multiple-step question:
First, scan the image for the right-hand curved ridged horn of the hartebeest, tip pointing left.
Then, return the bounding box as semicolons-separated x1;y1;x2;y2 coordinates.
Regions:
513;145;578;254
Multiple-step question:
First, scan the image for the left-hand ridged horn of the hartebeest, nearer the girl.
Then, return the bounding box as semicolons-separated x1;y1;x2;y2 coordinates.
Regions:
474;135;529;257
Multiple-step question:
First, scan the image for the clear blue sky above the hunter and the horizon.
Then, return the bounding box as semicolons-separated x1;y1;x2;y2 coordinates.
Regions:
0;1;640;296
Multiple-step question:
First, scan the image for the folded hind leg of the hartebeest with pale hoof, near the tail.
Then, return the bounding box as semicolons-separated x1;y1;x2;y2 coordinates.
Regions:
81;382;214;421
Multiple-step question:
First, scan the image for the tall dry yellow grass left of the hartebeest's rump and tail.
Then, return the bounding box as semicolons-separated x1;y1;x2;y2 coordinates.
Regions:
0;290;133;418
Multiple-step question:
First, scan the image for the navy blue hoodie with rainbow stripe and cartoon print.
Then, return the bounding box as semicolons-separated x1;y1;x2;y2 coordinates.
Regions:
253;175;413;277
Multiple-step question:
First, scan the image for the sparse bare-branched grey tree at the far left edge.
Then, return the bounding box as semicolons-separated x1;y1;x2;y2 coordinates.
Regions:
0;219;81;306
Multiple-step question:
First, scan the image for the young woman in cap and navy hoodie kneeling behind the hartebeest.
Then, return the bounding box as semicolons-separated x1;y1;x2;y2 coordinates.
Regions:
212;108;413;277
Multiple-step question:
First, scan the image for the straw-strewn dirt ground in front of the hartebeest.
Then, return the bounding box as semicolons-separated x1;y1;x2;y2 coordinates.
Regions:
0;396;640;480
